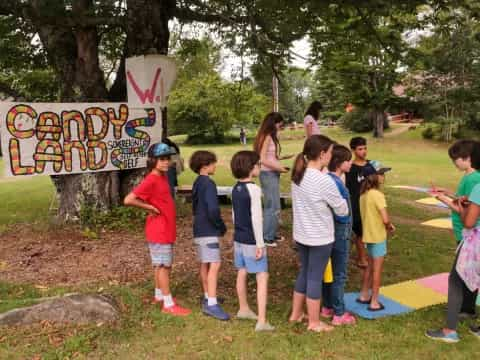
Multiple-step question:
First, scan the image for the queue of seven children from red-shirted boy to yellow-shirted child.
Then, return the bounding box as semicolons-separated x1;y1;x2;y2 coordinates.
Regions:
124;135;400;331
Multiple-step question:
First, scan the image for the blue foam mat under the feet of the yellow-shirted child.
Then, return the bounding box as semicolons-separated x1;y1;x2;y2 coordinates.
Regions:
344;293;415;319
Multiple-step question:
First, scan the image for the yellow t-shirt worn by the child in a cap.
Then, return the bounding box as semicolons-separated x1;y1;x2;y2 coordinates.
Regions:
360;189;387;243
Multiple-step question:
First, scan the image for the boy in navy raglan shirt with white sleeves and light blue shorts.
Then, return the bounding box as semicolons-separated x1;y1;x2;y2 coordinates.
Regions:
230;151;275;331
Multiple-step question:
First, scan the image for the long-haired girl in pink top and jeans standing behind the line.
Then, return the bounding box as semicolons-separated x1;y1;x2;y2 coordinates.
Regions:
253;112;293;246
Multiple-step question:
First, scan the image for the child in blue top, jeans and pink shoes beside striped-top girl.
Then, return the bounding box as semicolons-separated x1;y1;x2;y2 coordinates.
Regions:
321;145;356;325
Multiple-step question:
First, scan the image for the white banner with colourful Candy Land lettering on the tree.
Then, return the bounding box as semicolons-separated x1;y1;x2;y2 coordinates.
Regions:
0;103;162;176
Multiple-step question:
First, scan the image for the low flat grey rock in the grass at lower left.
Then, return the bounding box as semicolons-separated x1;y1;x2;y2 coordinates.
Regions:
0;294;119;326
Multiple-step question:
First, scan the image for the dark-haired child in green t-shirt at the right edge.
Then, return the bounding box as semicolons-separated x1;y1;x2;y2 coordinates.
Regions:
432;140;480;318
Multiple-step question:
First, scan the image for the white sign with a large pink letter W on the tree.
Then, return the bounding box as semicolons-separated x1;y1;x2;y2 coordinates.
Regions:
125;55;177;107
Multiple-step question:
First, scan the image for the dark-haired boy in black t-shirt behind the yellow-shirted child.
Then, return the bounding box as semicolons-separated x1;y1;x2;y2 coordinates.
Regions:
346;136;371;268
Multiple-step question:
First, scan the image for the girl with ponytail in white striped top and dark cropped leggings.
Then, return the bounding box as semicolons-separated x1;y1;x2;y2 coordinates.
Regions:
290;135;348;332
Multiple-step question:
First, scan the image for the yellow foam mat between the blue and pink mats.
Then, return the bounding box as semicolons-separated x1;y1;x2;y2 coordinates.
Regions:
380;280;447;309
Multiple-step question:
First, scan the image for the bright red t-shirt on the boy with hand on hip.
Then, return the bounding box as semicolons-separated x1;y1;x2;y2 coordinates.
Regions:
133;172;177;244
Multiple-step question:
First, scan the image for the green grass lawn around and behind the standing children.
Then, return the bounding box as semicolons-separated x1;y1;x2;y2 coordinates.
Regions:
0;125;479;359
